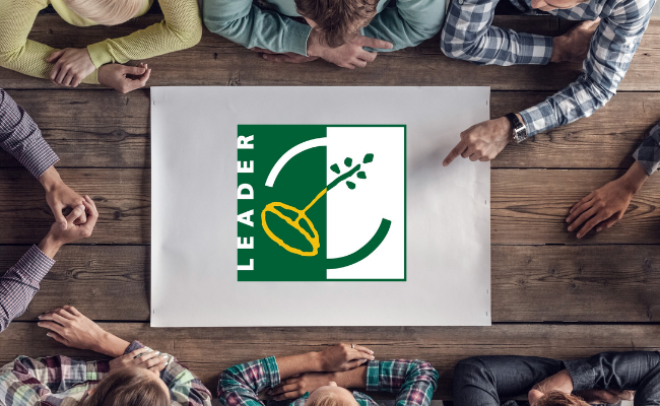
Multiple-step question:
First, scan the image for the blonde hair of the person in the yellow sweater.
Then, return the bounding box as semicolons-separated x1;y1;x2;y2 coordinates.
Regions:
64;0;147;25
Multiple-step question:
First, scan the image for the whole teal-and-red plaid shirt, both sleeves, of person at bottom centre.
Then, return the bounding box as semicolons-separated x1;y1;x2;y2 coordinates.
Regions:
218;357;438;406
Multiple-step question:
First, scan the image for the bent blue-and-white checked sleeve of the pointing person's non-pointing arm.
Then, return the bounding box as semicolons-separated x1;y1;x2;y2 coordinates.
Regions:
440;0;552;66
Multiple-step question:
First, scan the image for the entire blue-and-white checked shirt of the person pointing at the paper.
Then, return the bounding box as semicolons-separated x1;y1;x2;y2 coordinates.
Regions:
440;0;655;136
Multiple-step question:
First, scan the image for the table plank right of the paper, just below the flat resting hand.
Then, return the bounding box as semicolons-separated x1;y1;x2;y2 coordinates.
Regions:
491;245;660;323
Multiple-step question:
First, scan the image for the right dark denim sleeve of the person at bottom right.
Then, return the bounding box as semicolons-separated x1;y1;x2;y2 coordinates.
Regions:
564;351;660;398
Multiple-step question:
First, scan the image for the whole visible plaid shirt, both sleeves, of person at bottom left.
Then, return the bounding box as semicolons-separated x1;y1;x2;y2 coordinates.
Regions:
0;341;211;406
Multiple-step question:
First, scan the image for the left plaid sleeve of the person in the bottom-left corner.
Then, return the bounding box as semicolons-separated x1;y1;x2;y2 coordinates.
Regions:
0;356;110;406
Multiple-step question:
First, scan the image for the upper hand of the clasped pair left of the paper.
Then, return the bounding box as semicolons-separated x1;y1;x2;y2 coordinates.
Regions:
39;166;87;230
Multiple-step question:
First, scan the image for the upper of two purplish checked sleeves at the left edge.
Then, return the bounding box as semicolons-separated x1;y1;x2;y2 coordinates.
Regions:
0;89;59;179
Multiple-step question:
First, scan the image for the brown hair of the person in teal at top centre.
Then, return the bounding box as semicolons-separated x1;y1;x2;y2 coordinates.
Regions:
296;0;378;48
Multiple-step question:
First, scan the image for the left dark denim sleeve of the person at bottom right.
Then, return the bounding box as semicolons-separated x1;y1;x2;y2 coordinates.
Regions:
454;356;564;406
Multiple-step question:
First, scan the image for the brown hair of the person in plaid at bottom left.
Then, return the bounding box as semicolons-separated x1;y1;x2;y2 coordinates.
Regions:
85;368;170;406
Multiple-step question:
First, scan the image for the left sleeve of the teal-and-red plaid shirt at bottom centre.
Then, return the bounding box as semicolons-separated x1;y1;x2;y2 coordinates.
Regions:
218;357;280;406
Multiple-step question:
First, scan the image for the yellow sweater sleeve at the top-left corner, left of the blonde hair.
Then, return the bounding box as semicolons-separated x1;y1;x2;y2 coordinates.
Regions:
0;0;98;83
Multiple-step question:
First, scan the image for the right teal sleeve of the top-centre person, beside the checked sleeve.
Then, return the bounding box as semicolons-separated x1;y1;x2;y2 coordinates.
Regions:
362;0;446;52
